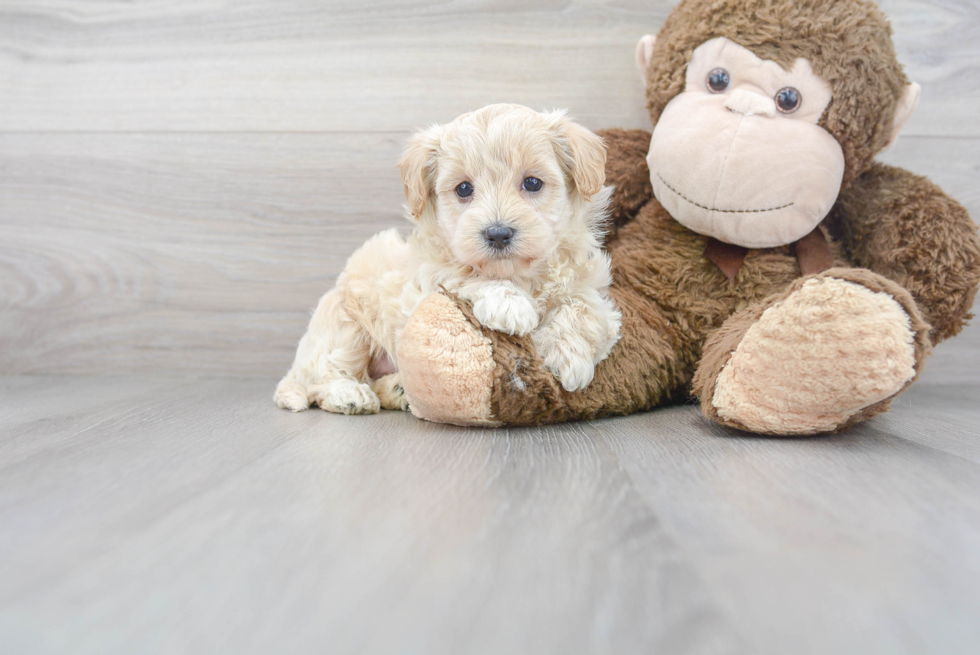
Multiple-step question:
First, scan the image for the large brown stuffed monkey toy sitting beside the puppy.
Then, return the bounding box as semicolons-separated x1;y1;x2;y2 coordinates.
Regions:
399;0;980;435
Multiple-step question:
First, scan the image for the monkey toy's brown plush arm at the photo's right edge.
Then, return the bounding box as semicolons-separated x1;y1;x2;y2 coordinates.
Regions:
831;164;980;343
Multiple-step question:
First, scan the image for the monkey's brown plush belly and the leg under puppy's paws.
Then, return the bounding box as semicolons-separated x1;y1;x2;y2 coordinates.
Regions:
484;200;844;425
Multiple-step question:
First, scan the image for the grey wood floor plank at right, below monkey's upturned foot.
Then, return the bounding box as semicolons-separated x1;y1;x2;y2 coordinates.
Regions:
602;394;980;653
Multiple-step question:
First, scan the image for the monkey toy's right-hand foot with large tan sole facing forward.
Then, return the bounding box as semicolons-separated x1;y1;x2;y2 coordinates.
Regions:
695;269;929;435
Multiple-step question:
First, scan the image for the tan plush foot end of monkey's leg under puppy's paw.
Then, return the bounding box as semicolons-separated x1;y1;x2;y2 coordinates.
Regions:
398;293;500;426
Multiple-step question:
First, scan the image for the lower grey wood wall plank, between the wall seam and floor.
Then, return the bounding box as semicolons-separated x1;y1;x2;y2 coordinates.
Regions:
0;133;980;379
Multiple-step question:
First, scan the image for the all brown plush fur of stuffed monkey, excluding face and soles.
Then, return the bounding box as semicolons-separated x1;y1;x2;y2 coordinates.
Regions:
400;0;980;434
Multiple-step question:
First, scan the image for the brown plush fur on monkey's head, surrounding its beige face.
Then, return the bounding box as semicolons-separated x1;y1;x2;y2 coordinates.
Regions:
647;0;908;188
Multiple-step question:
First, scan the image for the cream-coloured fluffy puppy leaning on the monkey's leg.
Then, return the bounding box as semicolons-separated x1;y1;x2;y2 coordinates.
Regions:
275;105;620;414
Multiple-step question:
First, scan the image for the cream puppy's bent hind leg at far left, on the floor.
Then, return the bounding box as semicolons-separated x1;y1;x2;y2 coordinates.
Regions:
273;287;381;414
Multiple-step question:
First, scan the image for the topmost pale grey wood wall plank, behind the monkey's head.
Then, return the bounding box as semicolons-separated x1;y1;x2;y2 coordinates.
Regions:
0;0;980;136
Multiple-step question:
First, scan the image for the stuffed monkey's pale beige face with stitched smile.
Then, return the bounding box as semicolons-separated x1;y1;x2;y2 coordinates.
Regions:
638;38;844;248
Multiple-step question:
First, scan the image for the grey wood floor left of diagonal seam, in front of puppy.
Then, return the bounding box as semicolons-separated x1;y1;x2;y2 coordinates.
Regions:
0;378;737;653
